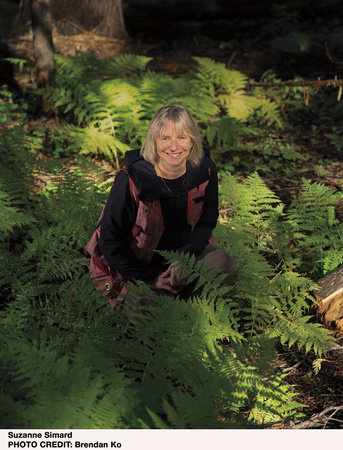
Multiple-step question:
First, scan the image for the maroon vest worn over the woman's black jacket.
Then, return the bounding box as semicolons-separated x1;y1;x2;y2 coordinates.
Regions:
85;171;214;307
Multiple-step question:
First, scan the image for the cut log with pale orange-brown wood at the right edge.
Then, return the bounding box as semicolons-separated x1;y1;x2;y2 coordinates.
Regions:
314;266;343;331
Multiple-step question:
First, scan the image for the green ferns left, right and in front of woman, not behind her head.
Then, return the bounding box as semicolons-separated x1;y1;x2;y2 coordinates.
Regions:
0;136;334;428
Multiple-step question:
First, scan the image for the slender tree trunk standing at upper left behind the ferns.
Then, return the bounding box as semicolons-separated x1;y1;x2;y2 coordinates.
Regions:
30;0;55;87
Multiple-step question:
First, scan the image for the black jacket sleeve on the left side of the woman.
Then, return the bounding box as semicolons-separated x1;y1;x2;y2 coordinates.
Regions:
99;171;157;283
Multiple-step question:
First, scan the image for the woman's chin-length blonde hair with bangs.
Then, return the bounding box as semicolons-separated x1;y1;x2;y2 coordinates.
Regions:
140;103;204;166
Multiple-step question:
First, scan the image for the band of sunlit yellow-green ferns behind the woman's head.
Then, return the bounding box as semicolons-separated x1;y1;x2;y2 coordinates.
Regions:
44;54;282;167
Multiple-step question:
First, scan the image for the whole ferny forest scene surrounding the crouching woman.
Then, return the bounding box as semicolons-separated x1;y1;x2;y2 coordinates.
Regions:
0;0;343;429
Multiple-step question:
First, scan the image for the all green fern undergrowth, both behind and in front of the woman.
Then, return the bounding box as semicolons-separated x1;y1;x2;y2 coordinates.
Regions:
0;51;343;429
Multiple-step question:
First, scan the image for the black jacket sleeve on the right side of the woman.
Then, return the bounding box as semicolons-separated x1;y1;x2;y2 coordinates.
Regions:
178;160;219;256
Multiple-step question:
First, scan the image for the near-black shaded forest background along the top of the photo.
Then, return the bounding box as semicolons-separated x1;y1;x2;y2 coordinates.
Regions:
0;0;343;79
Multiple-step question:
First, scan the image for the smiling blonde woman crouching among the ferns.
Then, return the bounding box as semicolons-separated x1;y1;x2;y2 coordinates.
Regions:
86;104;237;306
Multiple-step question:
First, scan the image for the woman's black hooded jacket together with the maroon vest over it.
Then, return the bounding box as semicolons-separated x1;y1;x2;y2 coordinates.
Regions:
86;150;218;302
